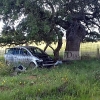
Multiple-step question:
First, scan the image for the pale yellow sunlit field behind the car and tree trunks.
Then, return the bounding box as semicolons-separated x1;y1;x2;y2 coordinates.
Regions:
0;40;100;57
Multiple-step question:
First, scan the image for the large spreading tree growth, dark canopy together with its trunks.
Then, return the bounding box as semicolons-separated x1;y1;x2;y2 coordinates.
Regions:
0;0;100;59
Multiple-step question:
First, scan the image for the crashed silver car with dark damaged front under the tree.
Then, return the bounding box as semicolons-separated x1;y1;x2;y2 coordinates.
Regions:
4;46;56;68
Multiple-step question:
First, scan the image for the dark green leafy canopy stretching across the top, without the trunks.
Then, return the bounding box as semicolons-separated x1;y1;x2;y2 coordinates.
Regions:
0;0;100;42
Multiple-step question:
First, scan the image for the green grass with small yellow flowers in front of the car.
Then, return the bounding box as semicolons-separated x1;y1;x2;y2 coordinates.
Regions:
0;59;100;100
